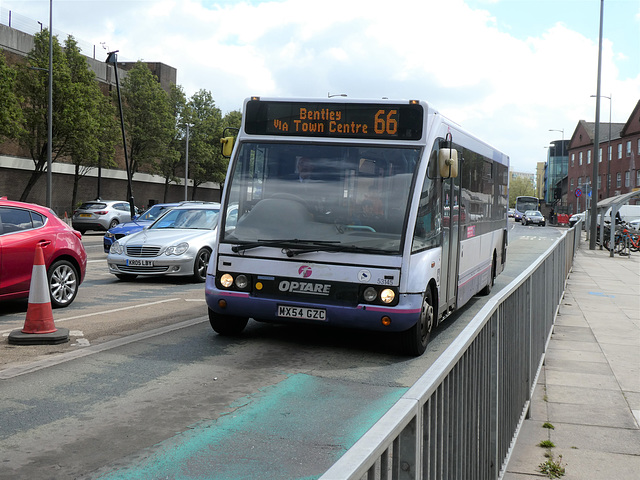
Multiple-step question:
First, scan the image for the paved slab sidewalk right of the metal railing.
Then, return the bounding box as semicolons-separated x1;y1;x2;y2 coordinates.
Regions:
504;241;640;480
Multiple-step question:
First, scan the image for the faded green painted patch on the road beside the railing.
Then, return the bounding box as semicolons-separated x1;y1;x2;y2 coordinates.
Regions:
92;374;407;480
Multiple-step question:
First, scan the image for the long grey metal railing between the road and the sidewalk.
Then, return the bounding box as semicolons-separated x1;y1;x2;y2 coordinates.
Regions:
320;223;581;480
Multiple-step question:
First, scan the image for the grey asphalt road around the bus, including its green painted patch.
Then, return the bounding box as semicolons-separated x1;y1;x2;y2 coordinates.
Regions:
0;222;561;479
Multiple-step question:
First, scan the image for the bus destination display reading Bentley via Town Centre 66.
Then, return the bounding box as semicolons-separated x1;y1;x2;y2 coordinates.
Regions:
245;100;423;140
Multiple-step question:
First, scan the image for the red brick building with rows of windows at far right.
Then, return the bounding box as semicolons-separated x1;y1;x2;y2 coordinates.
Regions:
566;100;640;213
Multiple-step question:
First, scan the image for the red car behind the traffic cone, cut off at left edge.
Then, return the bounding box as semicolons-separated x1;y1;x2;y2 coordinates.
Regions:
0;197;87;308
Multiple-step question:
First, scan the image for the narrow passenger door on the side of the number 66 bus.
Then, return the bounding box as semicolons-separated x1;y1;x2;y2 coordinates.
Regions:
438;178;460;313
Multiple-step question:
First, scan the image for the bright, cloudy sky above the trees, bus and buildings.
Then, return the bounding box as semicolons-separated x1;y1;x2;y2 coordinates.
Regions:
0;0;640;173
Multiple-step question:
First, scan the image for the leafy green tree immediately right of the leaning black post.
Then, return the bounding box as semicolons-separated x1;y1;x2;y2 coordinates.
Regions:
122;61;175;196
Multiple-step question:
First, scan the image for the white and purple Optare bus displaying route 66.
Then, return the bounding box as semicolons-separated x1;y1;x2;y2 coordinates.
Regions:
205;97;509;355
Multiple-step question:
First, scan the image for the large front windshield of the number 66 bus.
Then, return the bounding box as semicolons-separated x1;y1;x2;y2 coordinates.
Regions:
220;142;421;256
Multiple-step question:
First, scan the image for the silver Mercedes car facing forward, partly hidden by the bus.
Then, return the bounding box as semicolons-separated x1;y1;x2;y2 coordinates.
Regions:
107;203;220;282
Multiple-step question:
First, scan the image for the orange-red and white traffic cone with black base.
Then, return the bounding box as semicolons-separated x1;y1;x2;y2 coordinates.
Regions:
9;245;69;345
